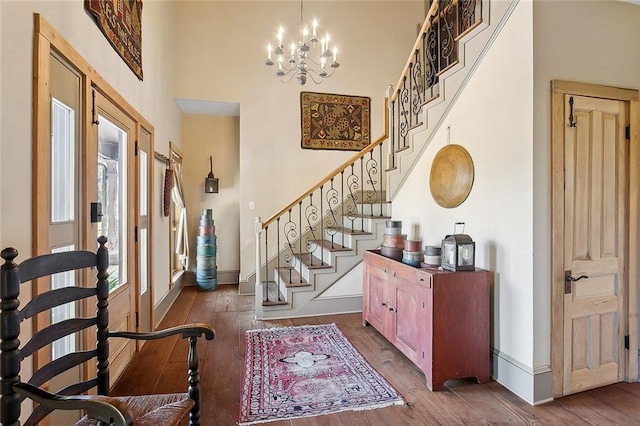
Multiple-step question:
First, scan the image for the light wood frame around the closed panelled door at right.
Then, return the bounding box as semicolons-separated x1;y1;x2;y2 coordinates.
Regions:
551;80;640;398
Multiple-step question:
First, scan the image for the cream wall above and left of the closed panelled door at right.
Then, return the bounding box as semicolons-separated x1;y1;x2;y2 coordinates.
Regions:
533;0;640;372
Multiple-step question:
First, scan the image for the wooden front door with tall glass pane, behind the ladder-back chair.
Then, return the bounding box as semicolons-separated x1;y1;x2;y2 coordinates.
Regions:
88;91;137;383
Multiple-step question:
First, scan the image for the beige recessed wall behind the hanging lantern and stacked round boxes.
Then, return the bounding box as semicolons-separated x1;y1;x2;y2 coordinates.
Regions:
182;114;240;274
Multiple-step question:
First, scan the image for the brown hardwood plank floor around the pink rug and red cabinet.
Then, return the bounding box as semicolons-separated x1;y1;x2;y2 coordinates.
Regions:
112;285;640;426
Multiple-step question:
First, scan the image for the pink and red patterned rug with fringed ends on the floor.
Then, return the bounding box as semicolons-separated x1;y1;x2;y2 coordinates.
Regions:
238;324;404;425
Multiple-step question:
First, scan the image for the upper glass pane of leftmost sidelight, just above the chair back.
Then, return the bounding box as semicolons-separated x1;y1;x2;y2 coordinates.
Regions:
51;98;75;223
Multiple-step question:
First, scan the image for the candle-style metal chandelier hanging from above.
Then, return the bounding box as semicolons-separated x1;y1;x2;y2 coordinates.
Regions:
265;0;340;86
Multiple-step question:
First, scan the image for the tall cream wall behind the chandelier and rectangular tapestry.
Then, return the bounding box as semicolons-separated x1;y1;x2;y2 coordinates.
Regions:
174;1;424;279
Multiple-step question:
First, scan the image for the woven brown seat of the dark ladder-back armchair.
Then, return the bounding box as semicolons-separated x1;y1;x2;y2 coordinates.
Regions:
76;393;195;426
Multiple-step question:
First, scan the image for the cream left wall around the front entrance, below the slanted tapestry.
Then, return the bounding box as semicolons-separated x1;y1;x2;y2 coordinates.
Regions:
0;0;180;310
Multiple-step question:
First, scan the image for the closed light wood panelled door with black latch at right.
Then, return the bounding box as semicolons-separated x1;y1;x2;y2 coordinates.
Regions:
563;95;628;395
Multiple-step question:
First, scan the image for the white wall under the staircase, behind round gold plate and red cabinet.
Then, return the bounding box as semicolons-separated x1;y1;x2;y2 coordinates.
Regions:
393;1;534;382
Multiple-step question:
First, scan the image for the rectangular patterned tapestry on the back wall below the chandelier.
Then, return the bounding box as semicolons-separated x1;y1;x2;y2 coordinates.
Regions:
300;92;371;151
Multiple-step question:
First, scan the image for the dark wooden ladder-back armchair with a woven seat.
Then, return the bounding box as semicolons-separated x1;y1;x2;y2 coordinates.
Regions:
0;237;214;426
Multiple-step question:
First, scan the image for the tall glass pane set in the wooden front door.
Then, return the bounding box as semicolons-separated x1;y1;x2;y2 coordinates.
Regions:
98;115;127;291
